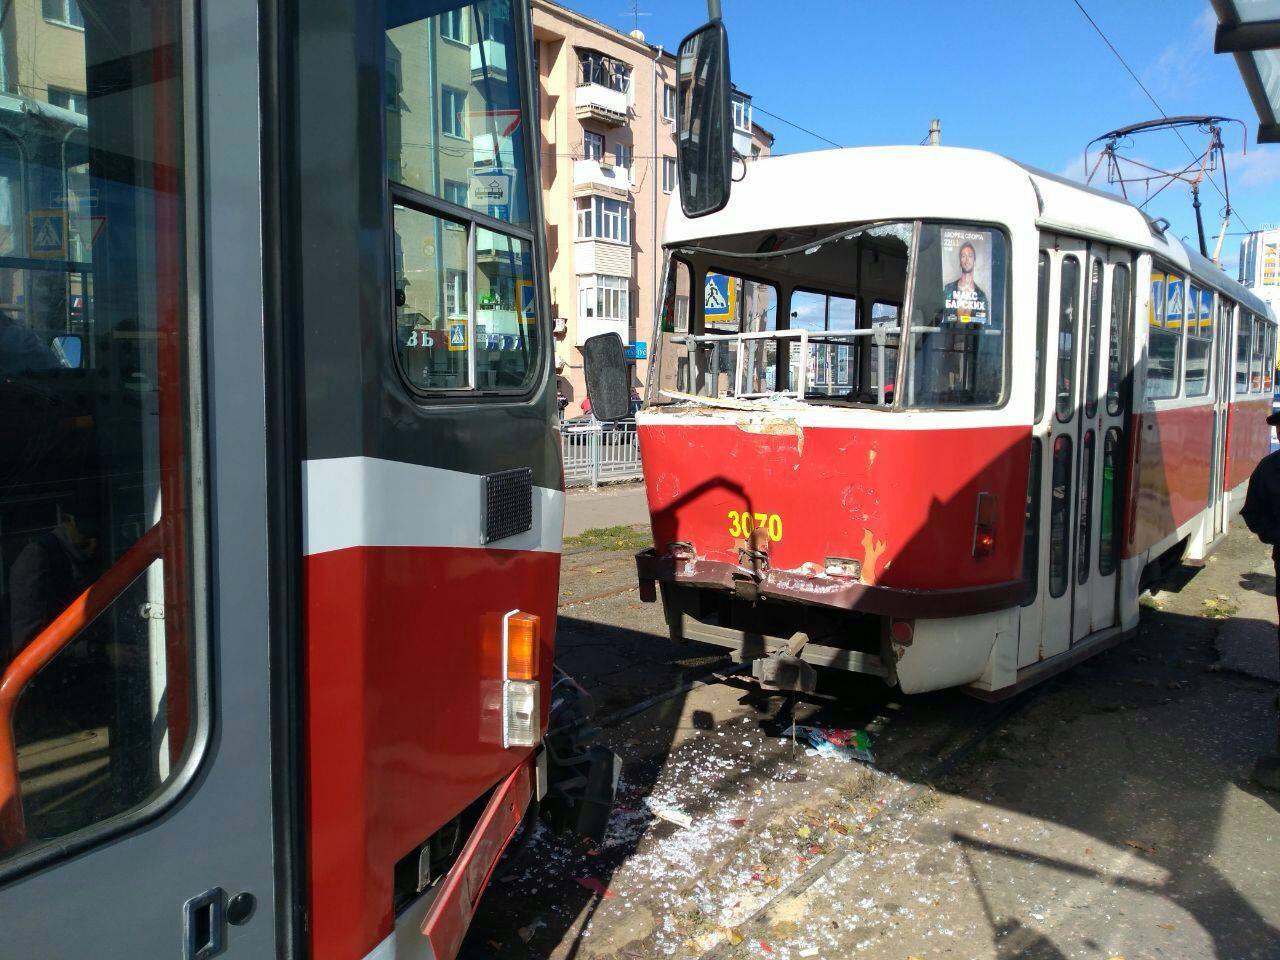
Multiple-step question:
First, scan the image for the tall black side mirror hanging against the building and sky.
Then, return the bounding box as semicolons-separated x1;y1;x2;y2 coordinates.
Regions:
676;20;733;216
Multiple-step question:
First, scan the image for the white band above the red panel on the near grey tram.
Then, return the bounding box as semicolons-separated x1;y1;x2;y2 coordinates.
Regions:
302;457;564;557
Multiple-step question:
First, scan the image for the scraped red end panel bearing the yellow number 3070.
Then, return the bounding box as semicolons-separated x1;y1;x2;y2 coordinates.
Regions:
640;422;1030;589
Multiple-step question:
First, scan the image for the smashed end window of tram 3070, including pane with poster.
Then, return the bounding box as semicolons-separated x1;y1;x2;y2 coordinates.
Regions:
648;221;1007;407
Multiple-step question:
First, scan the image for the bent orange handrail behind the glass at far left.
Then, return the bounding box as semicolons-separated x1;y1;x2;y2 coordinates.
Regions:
0;520;165;851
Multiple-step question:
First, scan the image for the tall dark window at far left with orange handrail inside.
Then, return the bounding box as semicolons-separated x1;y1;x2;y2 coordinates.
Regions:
0;0;200;870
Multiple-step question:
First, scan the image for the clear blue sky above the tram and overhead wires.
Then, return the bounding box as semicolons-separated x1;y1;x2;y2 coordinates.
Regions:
568;0;1280;271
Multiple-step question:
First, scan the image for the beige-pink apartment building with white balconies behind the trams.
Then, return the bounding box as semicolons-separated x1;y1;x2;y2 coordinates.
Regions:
532;0;773;416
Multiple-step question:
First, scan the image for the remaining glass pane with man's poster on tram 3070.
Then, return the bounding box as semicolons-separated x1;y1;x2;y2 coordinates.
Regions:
906;224;1007;407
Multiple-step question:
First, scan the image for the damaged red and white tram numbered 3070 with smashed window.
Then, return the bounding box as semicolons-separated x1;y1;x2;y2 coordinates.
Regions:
636;147;1276;695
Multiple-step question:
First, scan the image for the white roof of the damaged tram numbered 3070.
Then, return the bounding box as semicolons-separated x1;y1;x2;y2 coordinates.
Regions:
664;146;1268;314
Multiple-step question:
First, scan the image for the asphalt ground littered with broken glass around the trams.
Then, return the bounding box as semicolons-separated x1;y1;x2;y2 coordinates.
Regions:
467;534;1280;960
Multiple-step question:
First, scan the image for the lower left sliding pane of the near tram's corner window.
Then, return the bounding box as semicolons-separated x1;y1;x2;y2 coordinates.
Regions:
393;204;473;390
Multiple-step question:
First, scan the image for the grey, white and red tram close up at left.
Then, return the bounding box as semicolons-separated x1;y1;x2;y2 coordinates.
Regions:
0;0;586;960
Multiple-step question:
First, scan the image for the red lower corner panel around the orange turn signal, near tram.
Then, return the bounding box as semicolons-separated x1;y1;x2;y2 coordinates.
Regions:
305;547;559;960
